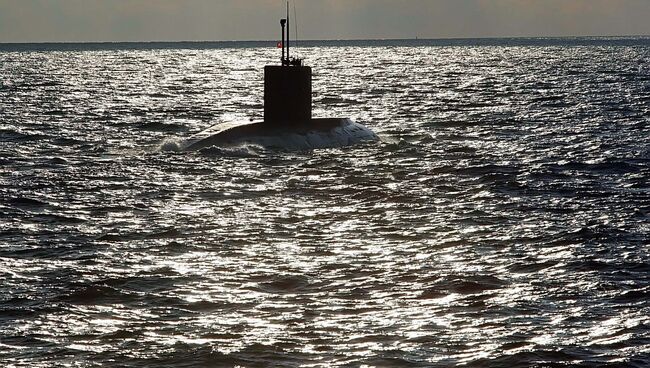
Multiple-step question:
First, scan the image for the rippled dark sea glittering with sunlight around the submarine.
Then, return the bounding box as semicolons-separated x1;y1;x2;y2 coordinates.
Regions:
0;38;650;367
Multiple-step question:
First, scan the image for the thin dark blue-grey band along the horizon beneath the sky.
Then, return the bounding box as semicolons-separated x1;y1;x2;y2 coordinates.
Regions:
0;35;650;51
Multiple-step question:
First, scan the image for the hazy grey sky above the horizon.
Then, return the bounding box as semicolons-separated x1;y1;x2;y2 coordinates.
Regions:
0;0;650;42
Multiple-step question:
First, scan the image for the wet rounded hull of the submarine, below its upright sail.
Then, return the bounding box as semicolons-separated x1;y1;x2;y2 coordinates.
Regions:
184;118;379;151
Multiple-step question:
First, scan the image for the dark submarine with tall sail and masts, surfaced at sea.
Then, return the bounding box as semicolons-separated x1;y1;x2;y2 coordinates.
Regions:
181;5;379;151
